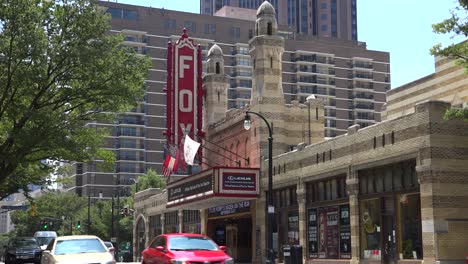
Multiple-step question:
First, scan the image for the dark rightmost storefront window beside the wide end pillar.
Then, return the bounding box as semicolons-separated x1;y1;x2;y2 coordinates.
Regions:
398;194;422;259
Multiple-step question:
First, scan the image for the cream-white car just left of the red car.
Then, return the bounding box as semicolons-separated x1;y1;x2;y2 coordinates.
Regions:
41;235;115;264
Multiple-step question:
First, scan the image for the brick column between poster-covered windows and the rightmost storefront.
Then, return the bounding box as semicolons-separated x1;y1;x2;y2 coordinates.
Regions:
346;167;361;264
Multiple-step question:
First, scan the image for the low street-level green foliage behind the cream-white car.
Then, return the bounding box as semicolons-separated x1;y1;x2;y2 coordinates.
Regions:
11;191;133;241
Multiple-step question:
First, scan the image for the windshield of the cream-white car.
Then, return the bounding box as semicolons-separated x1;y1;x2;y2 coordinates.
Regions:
55;238;107;255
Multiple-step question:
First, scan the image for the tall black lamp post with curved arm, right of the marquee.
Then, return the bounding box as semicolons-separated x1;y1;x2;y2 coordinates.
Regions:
244;111;275;263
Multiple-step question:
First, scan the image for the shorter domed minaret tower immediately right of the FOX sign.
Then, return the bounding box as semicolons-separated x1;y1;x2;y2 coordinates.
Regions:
203;44;229;131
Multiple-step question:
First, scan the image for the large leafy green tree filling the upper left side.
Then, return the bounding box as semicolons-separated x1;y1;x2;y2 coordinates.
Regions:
0;0;151;198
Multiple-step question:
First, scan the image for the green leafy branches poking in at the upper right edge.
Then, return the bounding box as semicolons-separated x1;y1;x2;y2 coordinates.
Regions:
430;0;468;121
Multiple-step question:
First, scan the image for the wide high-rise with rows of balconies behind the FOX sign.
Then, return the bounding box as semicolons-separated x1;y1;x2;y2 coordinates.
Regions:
69;1;390;198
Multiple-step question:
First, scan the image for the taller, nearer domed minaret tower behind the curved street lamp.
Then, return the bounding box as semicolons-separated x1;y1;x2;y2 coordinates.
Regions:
249;1;287;156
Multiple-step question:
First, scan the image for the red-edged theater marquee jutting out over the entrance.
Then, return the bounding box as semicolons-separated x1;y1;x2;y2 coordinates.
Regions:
166;167;260;210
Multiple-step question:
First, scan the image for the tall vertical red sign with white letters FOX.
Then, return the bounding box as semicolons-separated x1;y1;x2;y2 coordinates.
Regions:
164;28;204;159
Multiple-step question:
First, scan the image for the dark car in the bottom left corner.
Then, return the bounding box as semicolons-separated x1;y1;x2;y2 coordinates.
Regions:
4;237;42;264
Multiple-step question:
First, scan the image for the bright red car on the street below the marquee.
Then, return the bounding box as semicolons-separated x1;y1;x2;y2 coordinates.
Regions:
141;233;234;264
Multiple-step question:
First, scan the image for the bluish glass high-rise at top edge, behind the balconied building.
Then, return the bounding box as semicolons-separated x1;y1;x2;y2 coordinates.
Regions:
200;0;358;41
